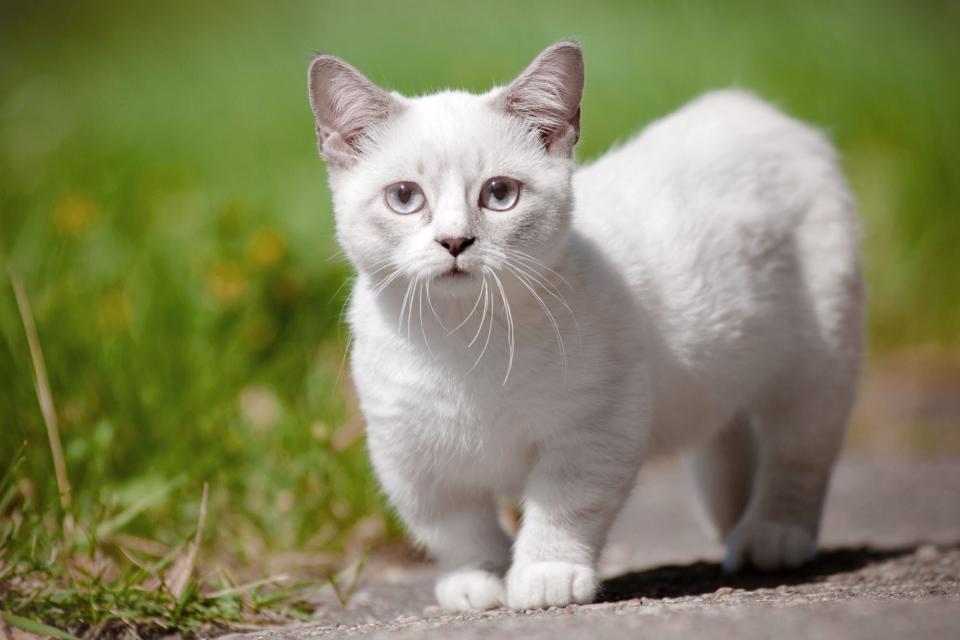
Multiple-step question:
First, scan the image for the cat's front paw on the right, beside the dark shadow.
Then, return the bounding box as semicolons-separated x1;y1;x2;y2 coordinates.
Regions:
507;562;597;609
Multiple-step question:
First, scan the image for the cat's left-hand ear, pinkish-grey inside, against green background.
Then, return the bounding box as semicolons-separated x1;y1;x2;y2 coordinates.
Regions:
308;54;399;166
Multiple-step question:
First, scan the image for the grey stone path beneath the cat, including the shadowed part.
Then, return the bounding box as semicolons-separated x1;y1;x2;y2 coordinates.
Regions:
232;453;960;640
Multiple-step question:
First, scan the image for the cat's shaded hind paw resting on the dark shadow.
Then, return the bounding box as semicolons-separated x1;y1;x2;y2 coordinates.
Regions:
723;522;817;572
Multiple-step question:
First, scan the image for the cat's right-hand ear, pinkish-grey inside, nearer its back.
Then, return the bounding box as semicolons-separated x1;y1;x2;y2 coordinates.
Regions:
500;41;583;155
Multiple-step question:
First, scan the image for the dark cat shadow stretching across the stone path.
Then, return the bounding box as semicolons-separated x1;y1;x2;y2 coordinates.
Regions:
598;546;917;602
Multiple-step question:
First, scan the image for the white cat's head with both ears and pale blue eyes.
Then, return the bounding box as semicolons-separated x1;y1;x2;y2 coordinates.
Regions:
309;42;583;295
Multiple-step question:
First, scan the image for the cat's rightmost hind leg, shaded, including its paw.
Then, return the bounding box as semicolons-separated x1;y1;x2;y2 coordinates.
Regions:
724;370;854;571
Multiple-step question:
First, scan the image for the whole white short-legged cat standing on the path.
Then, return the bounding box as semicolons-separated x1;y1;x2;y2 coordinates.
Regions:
309;42;863;610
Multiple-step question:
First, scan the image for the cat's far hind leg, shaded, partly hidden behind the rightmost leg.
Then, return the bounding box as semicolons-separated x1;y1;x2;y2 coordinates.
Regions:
691;413;756;540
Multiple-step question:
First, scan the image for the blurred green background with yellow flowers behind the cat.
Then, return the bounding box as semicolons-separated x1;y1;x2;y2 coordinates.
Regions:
0;0;960;568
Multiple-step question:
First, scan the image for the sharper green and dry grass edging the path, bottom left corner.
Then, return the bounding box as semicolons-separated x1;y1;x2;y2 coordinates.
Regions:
0;450;364;640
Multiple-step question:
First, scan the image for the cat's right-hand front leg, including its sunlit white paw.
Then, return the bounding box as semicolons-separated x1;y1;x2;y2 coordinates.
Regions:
507;434;639;609
